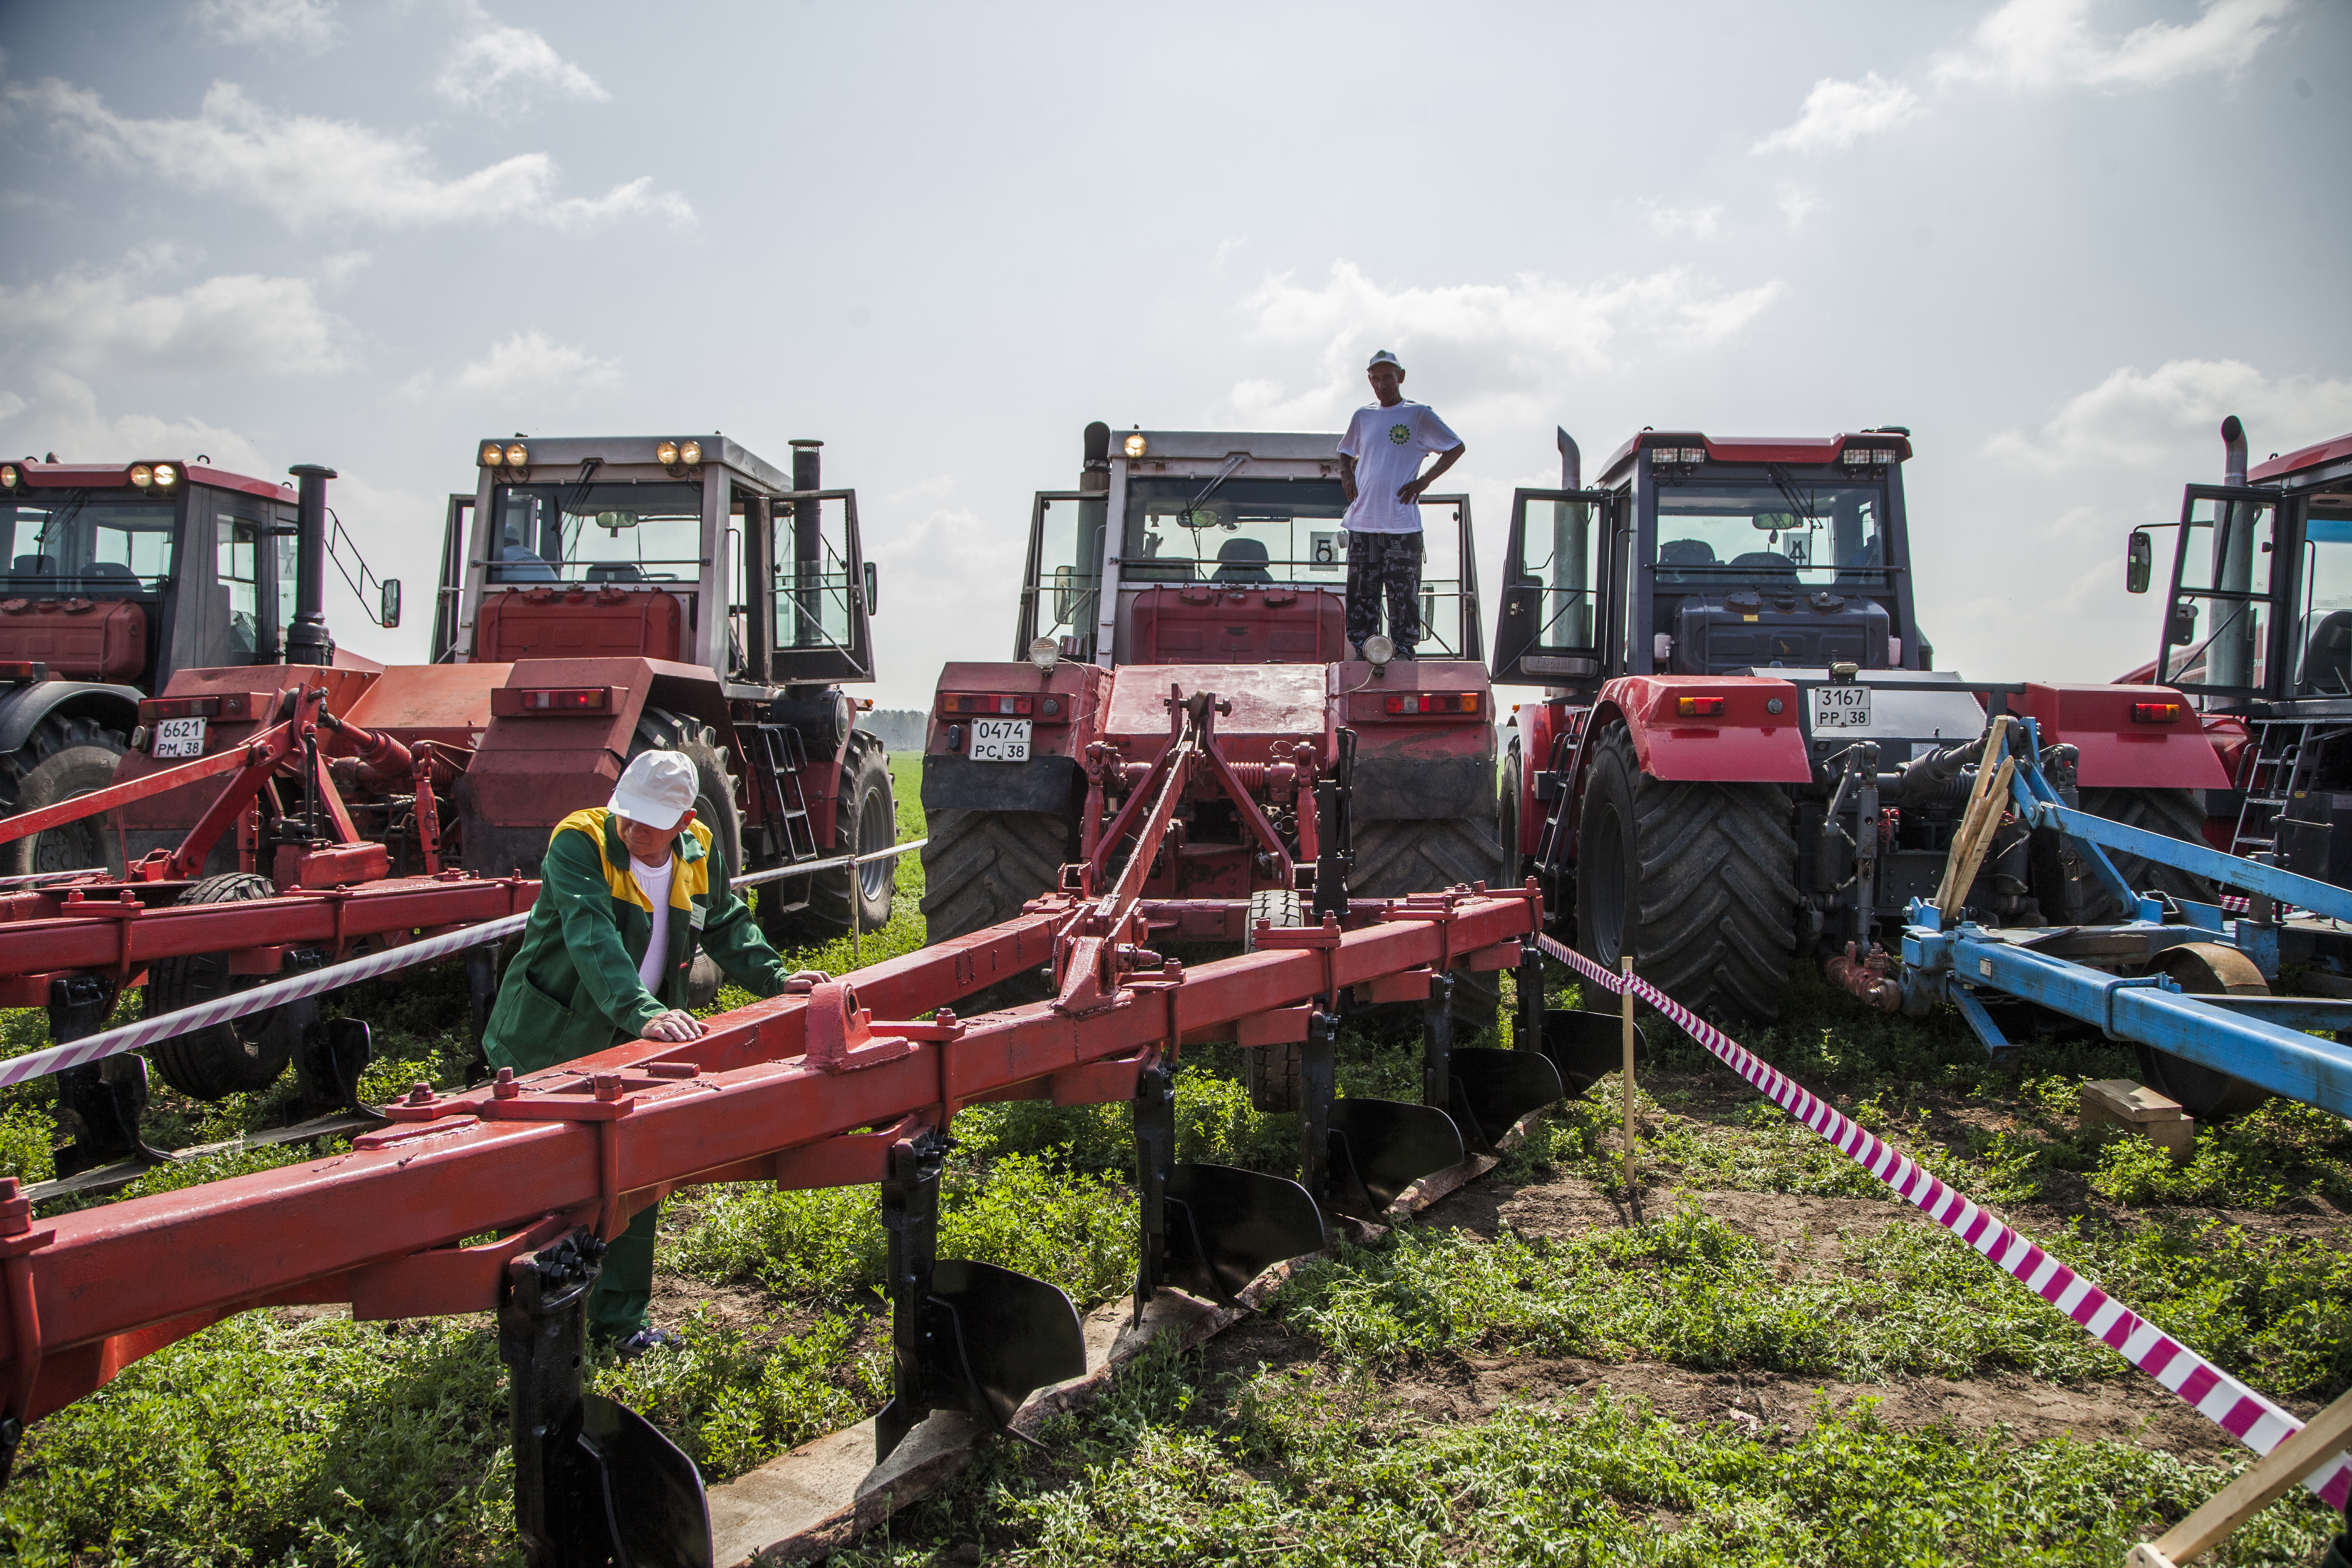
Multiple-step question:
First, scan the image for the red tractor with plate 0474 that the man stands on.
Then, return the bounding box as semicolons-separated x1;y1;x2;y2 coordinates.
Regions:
922;423;1501;1093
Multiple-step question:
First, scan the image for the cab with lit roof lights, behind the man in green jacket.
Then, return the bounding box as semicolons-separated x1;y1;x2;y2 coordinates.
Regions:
433;435;877;698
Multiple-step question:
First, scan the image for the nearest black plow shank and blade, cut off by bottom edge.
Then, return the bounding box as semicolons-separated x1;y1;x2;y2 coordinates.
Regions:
499;1230;713;1568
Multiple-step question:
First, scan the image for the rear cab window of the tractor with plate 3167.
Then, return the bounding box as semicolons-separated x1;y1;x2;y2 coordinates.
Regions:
1658;477;1886;590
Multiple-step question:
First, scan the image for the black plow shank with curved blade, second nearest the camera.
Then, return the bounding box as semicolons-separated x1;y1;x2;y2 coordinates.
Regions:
875;1128;1087;1465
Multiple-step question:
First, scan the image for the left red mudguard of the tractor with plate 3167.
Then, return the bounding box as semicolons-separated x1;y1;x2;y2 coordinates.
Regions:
1585;675;1813;783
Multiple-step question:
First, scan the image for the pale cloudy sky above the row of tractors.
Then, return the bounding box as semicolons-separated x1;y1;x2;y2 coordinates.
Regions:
0;0;2352;705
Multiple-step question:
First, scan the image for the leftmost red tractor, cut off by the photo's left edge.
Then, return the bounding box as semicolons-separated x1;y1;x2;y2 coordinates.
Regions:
0;456;400;877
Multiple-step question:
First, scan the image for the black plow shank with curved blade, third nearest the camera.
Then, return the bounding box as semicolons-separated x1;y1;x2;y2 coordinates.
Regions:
1134;1067;1324;1323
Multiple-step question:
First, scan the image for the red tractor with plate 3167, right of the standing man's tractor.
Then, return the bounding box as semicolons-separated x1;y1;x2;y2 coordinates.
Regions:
1493;428;2227;1020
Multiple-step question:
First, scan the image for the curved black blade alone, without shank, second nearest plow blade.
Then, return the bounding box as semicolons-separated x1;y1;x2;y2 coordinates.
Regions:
875;1258;1087;1457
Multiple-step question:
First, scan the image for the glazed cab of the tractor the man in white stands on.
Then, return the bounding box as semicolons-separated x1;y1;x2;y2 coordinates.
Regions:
1014;430;1484;668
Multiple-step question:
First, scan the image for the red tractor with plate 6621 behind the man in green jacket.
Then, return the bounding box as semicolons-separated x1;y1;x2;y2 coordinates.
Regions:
101;435;896;1098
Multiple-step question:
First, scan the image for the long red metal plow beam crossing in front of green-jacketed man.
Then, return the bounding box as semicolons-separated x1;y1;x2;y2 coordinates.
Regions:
0;891;1540;1415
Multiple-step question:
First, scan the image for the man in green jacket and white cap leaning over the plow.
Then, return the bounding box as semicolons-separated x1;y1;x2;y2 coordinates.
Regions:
482;752;790;1357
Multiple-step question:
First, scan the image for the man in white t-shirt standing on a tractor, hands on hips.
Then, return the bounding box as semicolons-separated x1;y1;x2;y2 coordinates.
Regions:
1338;348;1463;658
